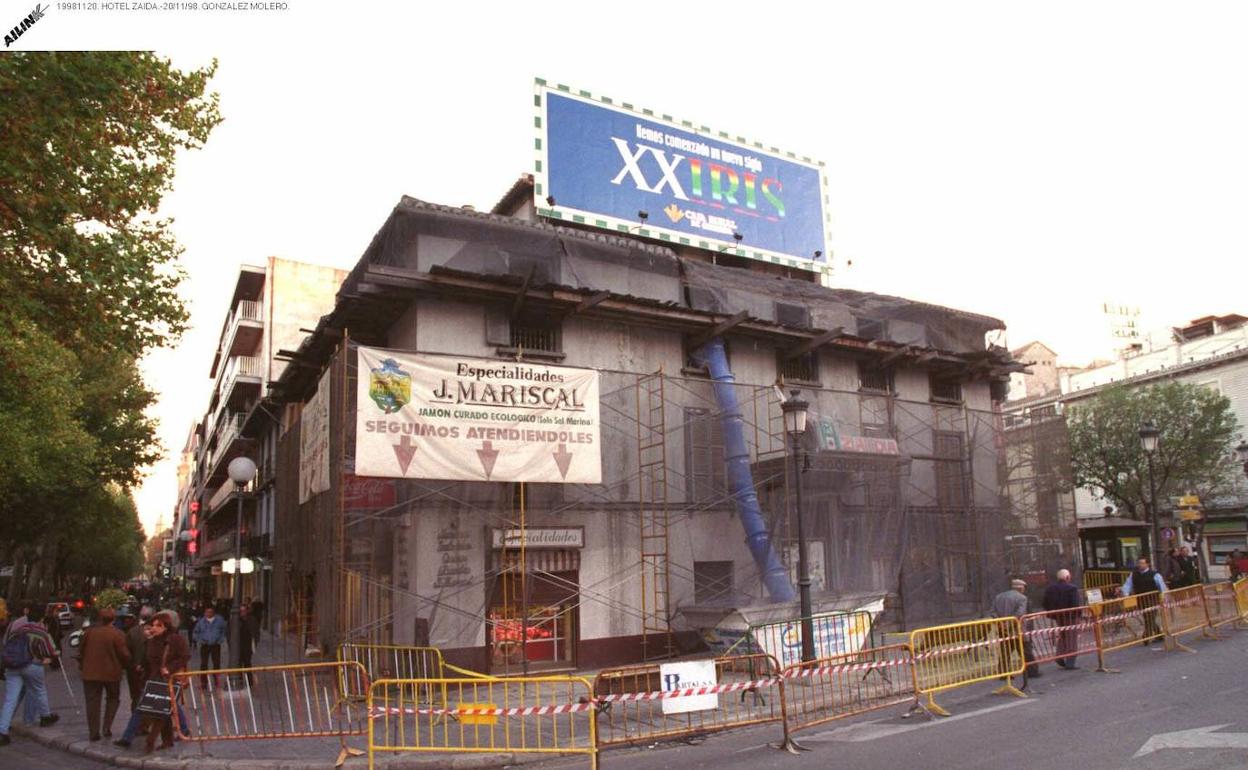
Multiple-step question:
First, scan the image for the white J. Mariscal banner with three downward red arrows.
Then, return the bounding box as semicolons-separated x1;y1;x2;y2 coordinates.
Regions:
356;347;603;484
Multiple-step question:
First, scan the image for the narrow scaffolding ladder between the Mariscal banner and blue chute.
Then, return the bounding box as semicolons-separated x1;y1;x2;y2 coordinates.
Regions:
636;369;673;660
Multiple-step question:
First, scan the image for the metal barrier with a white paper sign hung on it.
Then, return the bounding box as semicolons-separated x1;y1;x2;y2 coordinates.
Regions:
594;653;780;746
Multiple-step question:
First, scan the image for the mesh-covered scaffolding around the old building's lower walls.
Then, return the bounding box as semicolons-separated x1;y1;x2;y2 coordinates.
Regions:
280;342;1073;673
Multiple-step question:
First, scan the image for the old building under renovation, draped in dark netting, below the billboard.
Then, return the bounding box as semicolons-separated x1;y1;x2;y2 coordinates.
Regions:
258;180;1038;673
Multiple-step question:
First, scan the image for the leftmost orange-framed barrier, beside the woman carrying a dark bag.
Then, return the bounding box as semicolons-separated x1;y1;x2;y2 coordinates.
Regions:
170;661;368;764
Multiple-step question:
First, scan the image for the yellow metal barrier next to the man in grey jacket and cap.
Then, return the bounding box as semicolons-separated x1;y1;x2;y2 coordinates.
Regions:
910;618;1026;716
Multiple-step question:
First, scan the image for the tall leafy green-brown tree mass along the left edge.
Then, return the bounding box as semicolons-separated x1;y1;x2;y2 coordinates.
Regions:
0;52;221;595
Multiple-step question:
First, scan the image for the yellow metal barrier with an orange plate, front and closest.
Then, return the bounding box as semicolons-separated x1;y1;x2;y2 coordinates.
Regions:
368;676;598;770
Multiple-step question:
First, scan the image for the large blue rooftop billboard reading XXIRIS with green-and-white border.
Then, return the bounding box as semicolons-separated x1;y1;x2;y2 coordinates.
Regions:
534;81;829;271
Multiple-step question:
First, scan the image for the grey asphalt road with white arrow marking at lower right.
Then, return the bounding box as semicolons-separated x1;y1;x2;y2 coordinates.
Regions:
543;631;1248;770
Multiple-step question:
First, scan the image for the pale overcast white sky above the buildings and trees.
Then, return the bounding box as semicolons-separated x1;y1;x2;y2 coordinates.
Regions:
19;0;1248;529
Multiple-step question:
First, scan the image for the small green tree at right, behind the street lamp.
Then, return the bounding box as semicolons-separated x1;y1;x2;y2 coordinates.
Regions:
1066;381;1238;566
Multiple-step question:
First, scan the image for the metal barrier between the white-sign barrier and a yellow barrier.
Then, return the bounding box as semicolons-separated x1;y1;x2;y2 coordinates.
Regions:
780;644;919;753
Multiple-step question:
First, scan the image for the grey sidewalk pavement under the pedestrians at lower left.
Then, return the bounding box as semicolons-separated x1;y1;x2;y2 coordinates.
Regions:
8;626;536;770
